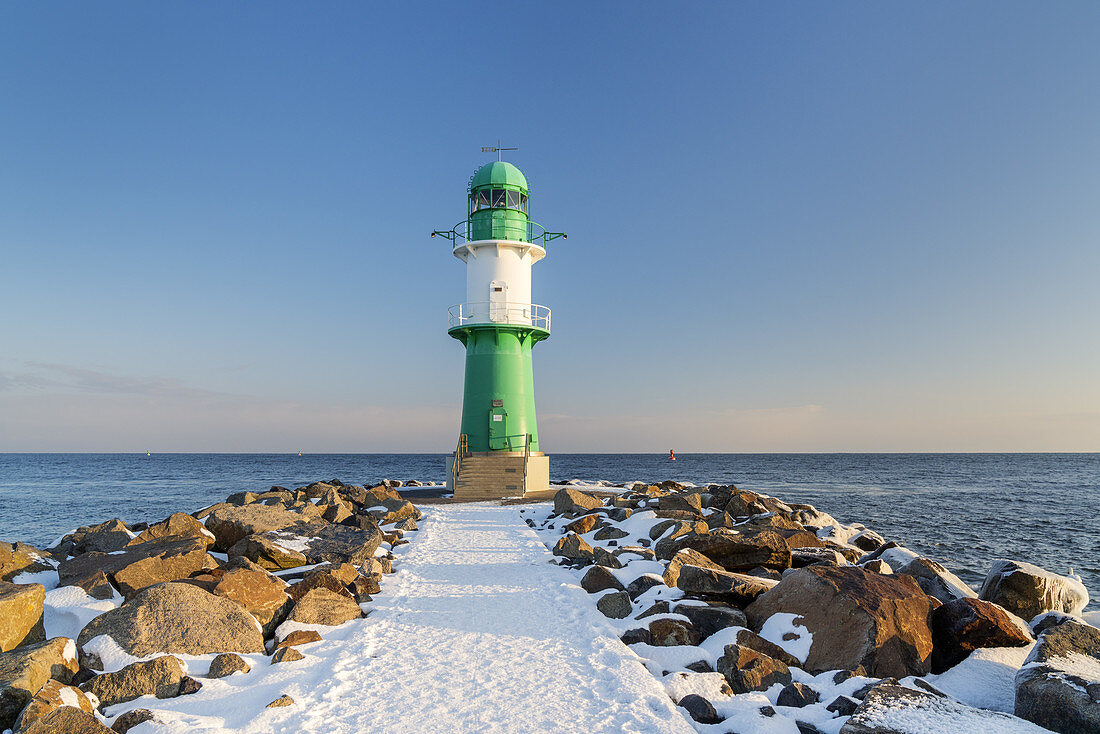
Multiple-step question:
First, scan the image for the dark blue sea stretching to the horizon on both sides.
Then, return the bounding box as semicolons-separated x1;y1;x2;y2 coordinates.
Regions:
0;453;1100;607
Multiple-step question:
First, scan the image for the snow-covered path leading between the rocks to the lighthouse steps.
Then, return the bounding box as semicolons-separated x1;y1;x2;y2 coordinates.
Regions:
124;504;694;734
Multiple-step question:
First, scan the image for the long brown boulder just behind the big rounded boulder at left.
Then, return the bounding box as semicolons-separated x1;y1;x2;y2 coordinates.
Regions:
57;537;209;599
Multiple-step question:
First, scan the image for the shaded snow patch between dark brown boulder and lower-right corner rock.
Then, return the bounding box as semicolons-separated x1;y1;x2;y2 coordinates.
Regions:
924;643;1035;713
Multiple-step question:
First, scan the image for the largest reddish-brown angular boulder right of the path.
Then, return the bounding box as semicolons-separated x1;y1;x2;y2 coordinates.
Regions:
745;566;933;677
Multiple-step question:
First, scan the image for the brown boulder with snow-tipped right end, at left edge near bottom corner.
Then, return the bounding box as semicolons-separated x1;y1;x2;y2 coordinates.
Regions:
0;637;80;731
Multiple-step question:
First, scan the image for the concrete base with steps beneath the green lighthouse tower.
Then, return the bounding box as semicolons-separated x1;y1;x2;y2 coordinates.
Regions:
447;451;550;501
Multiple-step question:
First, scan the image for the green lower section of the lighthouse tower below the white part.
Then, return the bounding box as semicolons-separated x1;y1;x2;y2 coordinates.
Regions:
449;325;550;451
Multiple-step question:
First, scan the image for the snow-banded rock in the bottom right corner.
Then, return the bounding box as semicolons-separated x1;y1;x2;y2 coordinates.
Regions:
1015;622;1100;734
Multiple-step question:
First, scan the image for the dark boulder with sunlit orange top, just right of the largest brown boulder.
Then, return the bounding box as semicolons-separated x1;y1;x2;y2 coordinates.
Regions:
931;598;1034;673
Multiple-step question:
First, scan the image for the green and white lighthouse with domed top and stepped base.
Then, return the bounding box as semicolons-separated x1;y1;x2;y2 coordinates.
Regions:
431;154;565;499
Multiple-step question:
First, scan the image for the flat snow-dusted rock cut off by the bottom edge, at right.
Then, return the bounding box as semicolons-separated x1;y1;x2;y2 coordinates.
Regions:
840;684;1048;734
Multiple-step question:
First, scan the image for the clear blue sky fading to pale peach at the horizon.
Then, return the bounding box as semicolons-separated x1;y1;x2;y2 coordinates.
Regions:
0;1;1100;453
